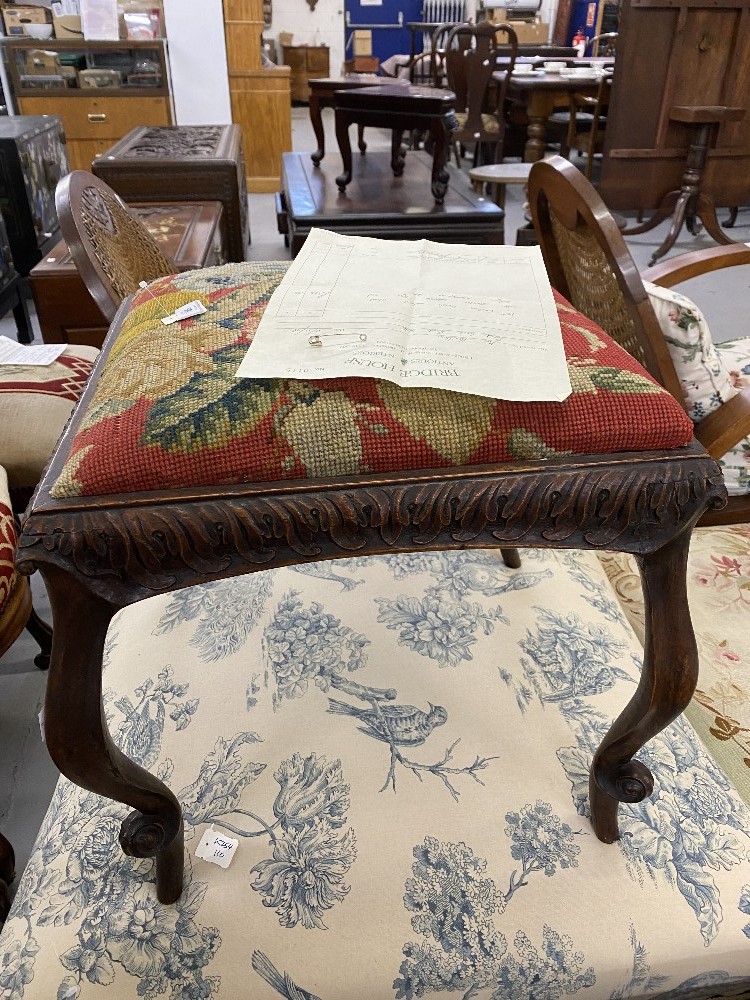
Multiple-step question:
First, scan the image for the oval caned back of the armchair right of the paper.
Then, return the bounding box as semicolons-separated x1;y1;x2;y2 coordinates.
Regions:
528;156;684;403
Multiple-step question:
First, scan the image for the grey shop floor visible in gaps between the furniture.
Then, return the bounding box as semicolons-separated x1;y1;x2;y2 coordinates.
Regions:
0;108;750;900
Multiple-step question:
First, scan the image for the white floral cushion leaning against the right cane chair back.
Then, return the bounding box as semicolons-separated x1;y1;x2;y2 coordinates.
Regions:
643;281;737;424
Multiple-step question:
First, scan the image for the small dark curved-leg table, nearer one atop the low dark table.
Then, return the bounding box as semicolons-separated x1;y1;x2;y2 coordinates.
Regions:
334;83;457;204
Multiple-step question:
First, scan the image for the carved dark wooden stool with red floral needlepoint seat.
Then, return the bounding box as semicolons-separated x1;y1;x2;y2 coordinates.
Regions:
18;263;726;902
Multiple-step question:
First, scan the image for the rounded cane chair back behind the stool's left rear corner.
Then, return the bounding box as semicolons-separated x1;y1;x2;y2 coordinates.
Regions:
55;170;177;321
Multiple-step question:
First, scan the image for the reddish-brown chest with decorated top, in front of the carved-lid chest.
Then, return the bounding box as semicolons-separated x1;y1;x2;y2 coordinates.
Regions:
29;201;224;347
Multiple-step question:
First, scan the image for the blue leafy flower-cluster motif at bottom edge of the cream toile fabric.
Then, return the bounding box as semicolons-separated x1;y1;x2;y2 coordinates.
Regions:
393;802;596;1000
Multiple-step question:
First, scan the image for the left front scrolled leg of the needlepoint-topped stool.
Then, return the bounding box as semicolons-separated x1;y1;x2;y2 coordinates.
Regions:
40;565;184;903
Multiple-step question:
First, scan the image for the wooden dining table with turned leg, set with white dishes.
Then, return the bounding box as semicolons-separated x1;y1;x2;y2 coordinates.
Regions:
506;59;611;163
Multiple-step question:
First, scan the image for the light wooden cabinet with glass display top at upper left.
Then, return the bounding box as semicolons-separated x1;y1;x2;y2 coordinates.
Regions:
5;39;172;170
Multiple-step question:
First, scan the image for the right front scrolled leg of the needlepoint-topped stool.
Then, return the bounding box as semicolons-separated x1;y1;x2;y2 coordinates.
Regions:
589;530;698;844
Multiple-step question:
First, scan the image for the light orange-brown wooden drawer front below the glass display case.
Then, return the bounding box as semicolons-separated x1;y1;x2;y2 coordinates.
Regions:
20;97;170;139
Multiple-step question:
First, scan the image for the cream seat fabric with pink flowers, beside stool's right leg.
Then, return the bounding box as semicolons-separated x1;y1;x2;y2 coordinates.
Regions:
601;524;750;806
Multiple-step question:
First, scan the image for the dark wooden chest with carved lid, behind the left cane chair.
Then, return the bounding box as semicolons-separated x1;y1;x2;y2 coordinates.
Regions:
91;125;250;261
